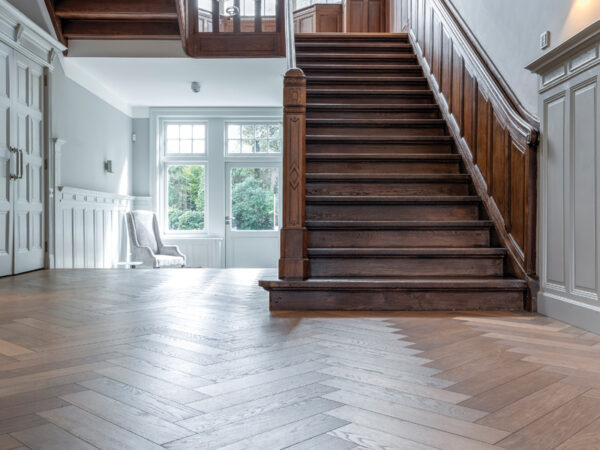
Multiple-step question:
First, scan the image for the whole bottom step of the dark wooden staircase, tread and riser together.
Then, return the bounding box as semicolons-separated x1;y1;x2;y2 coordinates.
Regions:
259;277;527;311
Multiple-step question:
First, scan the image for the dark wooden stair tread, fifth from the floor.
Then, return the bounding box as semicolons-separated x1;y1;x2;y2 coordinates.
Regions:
306;173;471;183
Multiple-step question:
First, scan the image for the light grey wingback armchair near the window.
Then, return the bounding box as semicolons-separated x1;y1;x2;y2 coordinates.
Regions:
127;211;186;269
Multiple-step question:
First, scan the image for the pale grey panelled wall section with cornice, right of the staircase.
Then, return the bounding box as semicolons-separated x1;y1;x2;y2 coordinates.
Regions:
532;25;600;332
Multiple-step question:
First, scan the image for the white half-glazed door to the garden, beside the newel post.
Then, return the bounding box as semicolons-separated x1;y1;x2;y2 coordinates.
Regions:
225;162;281;268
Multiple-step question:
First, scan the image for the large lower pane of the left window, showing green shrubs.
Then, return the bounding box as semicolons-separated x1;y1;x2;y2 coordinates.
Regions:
167;166;205;231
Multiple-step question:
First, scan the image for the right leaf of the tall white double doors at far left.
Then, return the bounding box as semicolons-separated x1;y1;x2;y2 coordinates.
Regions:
12;54;44;274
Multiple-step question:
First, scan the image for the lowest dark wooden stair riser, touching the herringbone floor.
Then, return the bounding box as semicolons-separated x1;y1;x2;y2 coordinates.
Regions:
269;289;524;311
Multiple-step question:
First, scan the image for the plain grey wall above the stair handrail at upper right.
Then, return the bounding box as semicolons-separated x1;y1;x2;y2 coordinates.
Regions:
447;0;600;117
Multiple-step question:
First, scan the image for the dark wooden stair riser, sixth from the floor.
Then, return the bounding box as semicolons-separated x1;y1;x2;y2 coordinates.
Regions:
306;160;460;175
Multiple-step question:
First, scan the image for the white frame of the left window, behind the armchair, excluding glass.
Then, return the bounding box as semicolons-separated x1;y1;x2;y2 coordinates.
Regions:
158;117;210;237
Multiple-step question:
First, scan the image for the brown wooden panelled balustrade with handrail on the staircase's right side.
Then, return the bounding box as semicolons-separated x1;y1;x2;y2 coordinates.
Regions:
408;0;539;309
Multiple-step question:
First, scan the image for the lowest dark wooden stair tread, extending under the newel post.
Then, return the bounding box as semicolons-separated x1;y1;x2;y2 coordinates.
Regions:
260;276;527;291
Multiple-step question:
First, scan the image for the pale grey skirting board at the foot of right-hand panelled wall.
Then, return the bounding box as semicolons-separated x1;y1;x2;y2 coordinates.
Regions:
538;291;600;334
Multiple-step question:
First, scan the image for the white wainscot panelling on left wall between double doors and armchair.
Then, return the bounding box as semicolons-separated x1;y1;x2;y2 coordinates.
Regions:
55;187;133;269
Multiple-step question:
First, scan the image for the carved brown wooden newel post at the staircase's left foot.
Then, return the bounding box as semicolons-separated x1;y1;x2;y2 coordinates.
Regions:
279;69;309;280
